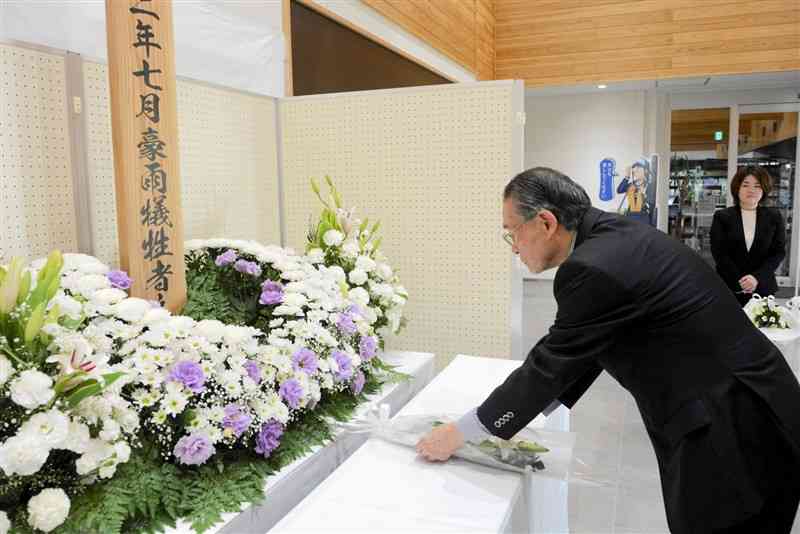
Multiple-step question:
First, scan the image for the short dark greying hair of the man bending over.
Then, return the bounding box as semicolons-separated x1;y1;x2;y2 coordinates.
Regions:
503;167;592;231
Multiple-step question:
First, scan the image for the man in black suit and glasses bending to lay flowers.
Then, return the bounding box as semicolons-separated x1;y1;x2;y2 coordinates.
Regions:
417;168;800;534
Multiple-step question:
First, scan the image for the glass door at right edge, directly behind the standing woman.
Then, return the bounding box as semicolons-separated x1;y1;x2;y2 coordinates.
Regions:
736;104;800;296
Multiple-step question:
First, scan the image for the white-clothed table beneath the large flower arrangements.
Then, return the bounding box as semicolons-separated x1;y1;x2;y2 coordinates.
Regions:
167;351;436;534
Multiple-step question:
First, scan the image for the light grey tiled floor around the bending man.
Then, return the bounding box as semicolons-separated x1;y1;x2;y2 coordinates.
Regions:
523;282;800;534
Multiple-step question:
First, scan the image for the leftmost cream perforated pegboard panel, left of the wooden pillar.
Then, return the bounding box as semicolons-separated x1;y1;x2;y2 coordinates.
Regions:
0;45;77;262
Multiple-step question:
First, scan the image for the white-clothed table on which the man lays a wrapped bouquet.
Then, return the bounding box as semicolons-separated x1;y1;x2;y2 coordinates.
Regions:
270;355;568;534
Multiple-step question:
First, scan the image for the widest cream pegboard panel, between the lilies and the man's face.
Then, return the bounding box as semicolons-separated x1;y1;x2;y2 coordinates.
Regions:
280;82;513;366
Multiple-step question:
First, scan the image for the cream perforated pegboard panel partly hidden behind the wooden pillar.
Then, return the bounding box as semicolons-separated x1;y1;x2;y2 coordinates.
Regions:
84;62;280;264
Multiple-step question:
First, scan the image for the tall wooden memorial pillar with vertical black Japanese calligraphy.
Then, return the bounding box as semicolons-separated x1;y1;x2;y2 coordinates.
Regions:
106;0;186;312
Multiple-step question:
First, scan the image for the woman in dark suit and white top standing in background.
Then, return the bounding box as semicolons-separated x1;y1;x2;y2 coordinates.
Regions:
711;167;786;305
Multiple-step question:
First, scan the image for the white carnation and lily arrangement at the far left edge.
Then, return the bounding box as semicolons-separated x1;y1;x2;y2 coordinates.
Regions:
0;253;139;532
